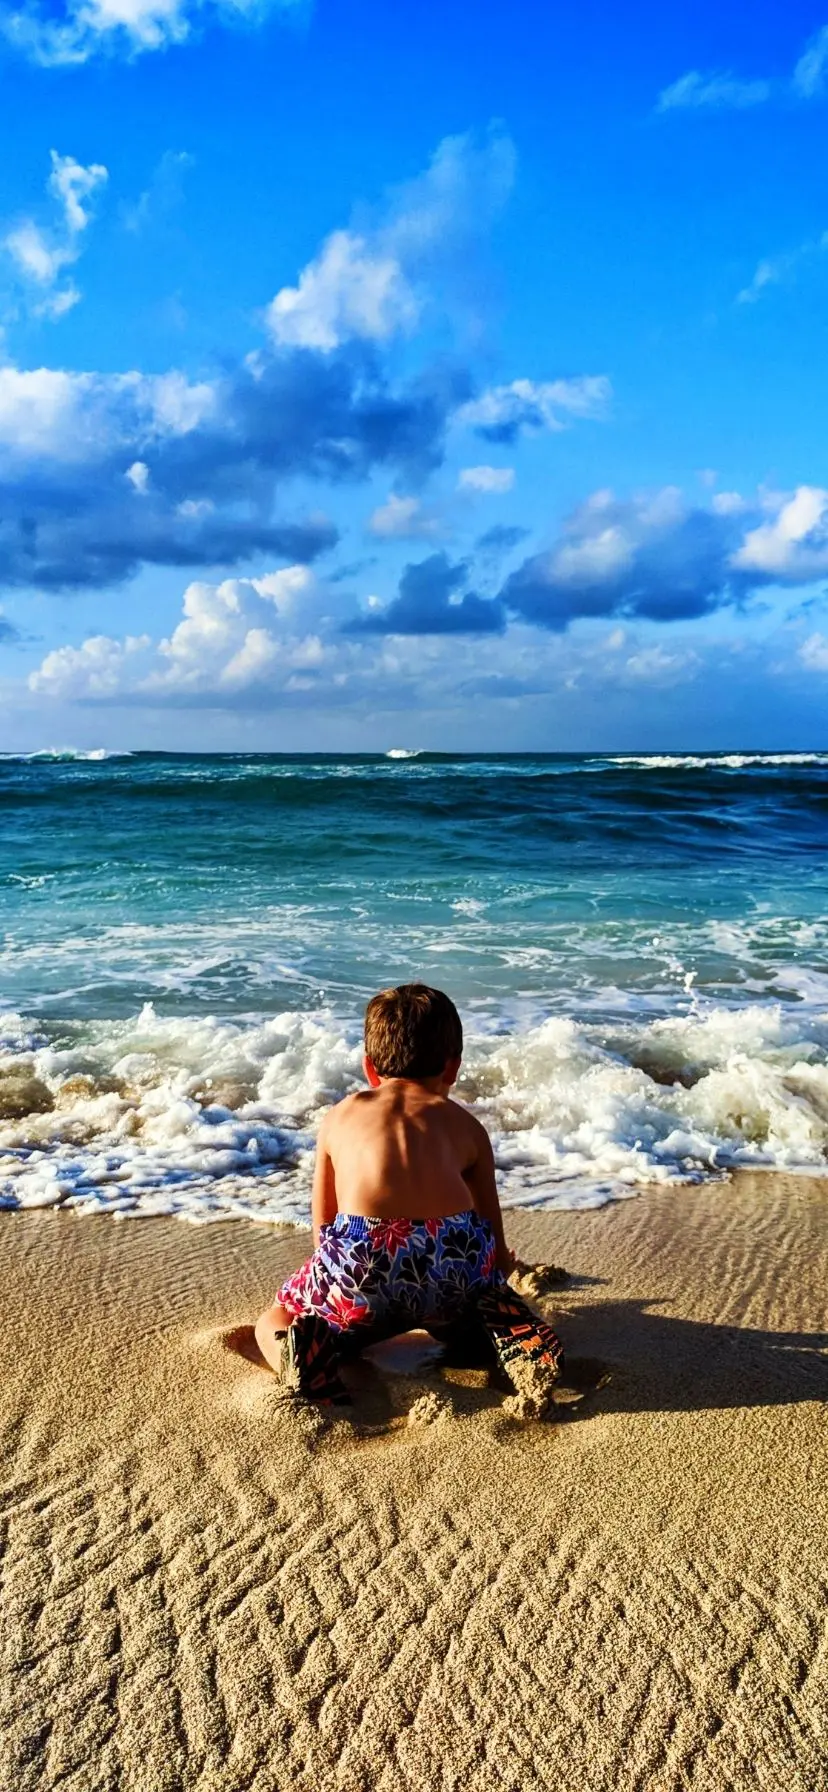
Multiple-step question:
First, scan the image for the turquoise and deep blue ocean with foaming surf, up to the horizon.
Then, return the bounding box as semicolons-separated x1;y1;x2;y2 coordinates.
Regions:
0;749;828;1222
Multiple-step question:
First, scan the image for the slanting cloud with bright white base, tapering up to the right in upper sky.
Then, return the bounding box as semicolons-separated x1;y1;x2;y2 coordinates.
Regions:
265;131;514;351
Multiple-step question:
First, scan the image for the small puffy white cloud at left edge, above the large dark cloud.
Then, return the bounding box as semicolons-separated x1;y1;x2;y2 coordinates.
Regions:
2;149;109;319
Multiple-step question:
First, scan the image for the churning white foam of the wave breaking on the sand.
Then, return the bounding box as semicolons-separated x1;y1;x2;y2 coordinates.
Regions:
0;1004;828;1222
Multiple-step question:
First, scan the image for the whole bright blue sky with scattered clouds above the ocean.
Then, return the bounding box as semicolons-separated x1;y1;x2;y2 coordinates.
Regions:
0;0;828;751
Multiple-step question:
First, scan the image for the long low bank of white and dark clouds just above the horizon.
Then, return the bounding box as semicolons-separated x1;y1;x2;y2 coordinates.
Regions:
29;486;828;711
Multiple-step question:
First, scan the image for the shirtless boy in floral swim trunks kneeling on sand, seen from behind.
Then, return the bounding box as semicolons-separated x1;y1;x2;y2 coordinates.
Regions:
256;984;561;1401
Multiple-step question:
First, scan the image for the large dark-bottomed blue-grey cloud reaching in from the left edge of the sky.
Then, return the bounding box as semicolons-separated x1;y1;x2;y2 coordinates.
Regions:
0;338;457;588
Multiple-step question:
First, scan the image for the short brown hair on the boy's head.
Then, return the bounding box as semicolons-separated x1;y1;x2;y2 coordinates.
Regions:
366;984;462;1081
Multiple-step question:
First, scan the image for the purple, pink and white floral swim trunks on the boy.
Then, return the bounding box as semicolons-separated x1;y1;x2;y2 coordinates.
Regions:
276;1208;505;1331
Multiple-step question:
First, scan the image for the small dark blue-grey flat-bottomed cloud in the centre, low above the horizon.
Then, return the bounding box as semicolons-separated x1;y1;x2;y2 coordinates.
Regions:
344;554;505;634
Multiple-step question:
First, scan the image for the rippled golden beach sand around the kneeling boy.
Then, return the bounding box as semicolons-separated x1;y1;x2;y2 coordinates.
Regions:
0;1177;828;1792
